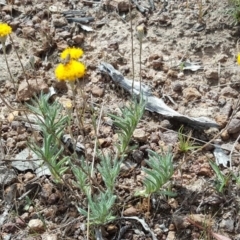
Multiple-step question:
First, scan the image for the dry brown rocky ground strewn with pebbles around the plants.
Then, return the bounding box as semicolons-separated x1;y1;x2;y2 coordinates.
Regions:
0;0;240;240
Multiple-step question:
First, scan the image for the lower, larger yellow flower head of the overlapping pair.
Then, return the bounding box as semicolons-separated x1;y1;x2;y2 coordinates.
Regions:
55;60;86;82
